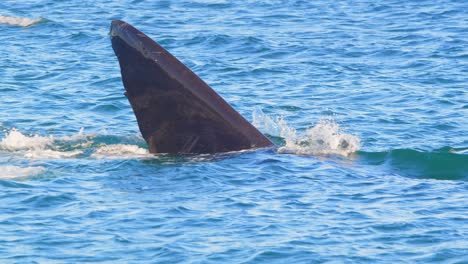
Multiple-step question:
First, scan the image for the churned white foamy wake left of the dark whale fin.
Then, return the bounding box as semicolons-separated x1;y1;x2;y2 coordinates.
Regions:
0;129;154;179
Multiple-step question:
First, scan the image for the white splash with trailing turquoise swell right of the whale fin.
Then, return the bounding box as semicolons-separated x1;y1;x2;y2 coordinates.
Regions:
253;111;468;180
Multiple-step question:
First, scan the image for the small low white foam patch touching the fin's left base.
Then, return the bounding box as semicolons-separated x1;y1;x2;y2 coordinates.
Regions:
91;144;154;159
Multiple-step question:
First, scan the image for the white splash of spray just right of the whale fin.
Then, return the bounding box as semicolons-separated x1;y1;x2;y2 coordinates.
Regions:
253;111;360;156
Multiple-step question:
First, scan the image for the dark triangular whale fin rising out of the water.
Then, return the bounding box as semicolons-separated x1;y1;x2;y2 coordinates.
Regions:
110;20;273;154
